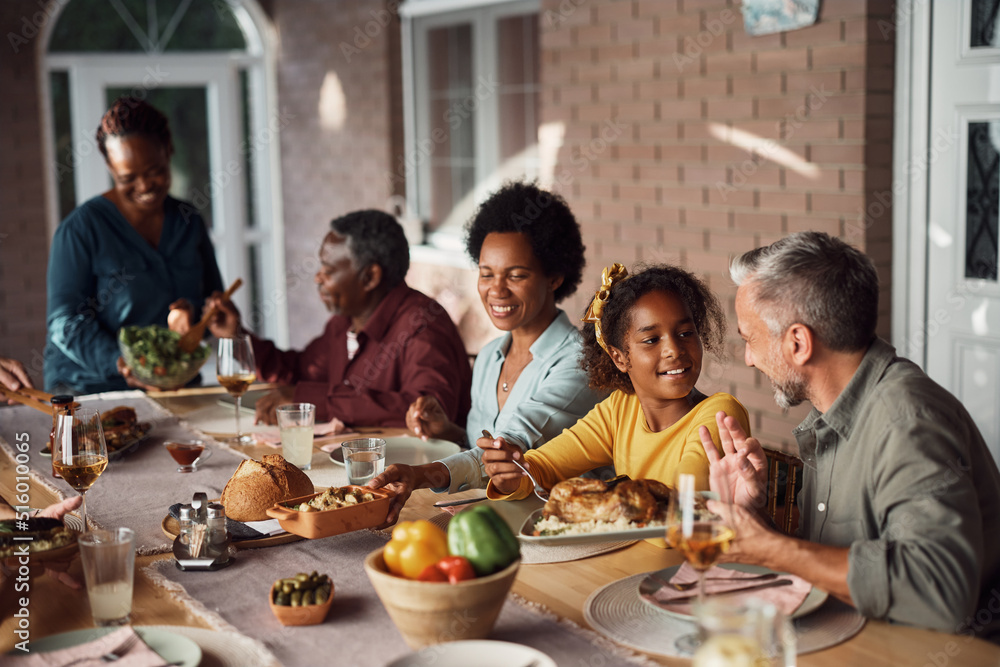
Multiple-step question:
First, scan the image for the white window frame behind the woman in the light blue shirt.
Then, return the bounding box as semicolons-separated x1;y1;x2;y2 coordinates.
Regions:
399;0;541;267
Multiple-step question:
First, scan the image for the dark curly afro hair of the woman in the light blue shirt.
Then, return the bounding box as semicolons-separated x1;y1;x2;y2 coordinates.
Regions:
465;182;586;303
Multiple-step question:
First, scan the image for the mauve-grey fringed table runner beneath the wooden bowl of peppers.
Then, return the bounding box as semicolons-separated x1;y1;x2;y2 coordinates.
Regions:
147;530;654;667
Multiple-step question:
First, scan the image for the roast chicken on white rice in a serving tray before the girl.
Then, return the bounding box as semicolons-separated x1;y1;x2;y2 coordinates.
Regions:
517;477;670;546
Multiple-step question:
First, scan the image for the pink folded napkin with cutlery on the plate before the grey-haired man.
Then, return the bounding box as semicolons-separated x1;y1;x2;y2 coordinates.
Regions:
643;563;812;616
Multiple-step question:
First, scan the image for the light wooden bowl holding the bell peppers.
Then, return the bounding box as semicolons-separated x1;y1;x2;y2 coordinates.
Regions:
365;549;521;649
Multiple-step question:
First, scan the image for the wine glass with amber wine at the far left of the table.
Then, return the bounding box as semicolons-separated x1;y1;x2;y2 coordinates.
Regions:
52;408;108;532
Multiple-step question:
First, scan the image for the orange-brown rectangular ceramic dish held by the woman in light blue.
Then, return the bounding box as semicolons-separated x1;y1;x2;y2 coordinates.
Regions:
267;485;395;540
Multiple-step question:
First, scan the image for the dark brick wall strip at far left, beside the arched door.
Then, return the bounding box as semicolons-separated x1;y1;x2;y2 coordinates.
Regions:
0;0;48;386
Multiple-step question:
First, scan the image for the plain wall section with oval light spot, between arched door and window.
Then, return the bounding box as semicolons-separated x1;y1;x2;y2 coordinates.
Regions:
272;0;399;347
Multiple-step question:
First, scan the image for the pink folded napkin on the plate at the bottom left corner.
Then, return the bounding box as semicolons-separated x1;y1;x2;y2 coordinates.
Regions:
4;625;167;667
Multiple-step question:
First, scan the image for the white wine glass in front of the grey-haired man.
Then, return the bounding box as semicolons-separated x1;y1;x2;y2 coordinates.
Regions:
667;474;736;655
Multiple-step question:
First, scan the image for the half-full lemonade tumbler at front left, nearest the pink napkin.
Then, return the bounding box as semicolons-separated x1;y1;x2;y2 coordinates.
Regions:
79;528;135;627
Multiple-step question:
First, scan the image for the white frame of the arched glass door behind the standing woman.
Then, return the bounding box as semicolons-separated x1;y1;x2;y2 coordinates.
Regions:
36;0;289;346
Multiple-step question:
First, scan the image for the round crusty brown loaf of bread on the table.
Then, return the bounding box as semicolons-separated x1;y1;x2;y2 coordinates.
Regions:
222;454;313;521
